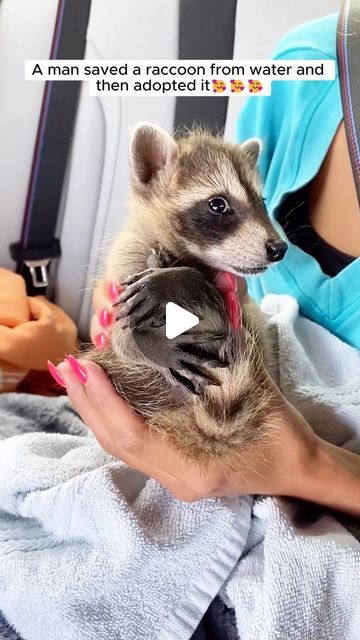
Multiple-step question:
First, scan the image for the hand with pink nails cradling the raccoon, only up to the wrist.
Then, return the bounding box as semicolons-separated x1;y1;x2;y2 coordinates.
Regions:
44;279;317;501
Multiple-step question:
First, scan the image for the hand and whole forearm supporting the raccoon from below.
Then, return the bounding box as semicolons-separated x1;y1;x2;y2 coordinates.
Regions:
52;284;360;515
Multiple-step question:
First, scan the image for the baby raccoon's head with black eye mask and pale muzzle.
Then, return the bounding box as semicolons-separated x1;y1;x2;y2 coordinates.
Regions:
131;125;287;276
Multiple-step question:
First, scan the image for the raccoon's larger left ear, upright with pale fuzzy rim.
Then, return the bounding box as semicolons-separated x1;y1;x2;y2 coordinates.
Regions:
130;123;178;186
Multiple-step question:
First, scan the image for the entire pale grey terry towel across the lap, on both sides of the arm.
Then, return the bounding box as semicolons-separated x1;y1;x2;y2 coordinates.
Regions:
0;296;360;640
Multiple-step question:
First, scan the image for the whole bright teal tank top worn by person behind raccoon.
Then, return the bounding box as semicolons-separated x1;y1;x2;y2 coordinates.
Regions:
237;14;360;349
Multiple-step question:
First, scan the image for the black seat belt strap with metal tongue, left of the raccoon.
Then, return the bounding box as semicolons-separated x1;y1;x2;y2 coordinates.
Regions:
10;0;91;295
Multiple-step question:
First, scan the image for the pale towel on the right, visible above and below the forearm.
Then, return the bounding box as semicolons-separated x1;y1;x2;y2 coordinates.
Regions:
223;295;360;640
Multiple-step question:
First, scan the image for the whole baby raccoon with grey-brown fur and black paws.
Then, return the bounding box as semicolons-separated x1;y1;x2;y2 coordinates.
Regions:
89;124;287;463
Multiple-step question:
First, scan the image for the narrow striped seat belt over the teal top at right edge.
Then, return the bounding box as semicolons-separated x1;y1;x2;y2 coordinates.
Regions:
337;0;360;205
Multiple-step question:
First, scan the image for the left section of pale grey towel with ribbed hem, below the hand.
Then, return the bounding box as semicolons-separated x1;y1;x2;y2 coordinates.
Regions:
0;404;251;640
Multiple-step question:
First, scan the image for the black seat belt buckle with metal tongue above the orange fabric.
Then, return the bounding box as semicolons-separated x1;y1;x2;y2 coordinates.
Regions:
10;238;61;289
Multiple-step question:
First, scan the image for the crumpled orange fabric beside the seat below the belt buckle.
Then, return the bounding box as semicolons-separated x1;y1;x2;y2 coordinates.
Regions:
0;268;77;391
